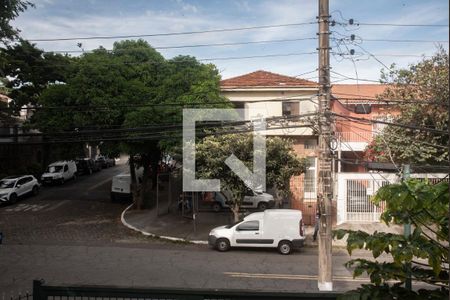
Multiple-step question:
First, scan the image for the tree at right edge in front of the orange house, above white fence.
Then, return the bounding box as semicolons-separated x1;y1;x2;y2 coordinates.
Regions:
366;48;449;164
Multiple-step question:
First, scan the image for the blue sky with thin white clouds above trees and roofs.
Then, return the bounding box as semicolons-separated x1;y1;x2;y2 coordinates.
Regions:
12;0;449;83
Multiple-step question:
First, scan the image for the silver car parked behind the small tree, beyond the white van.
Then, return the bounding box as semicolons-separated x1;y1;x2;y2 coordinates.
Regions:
206;189;275;212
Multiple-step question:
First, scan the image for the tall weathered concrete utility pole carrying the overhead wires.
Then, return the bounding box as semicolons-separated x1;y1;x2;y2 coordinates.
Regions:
317;0;333;291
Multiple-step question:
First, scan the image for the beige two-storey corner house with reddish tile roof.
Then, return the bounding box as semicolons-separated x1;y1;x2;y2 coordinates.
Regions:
220;71;318;223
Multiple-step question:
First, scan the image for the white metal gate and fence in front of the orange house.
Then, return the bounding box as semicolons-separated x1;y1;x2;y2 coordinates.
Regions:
336;173;448;224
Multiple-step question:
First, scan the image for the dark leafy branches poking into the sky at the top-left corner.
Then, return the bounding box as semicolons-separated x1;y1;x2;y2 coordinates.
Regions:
0;0;34;44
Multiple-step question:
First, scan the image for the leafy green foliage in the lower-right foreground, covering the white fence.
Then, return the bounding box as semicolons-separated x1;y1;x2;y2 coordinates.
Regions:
334;179;450;299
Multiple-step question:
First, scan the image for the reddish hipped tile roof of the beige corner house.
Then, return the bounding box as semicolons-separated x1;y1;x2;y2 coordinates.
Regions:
220;70;318;88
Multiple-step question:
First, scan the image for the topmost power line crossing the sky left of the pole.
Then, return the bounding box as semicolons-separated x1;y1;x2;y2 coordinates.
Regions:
28;22;317;42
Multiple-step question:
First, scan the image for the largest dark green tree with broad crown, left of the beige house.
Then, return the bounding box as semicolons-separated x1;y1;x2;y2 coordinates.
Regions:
32;40;230;207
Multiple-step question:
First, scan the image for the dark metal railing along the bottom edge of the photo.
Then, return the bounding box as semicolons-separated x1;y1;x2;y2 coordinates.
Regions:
33;280;340;300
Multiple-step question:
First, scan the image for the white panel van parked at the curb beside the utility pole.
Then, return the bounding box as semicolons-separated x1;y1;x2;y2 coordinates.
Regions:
208;209;305;255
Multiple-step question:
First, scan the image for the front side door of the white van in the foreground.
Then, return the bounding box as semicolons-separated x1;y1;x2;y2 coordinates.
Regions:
233;220;273;247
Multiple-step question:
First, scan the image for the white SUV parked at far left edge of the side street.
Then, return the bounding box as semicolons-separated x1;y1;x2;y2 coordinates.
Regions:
0;175;40;203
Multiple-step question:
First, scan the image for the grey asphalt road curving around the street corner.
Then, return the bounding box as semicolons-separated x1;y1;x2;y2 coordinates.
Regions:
0;165;370;299
